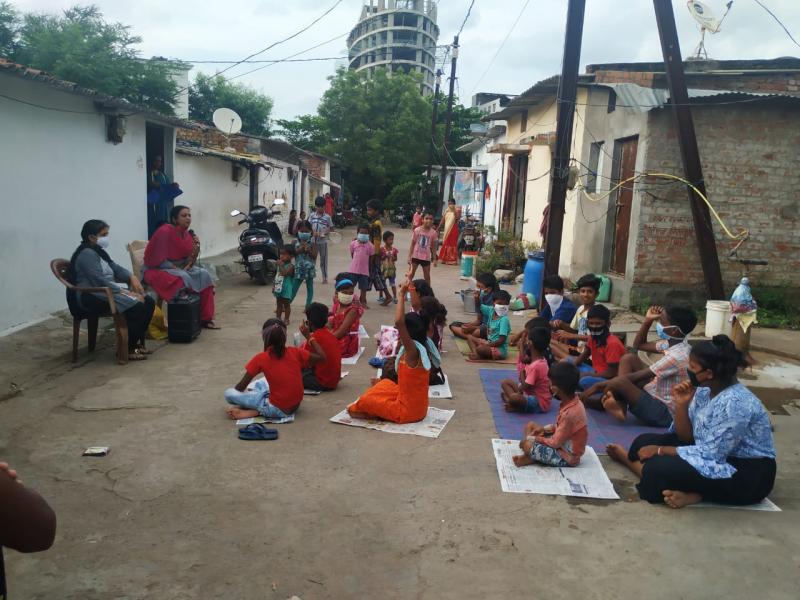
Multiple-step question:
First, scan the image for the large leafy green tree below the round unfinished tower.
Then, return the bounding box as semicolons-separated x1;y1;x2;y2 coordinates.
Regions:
319;68;431;200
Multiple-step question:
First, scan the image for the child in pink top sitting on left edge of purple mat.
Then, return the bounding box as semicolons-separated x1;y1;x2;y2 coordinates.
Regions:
500;327;553;413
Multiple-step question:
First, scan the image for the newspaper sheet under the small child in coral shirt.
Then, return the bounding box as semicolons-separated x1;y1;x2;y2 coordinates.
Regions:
492;439;619;500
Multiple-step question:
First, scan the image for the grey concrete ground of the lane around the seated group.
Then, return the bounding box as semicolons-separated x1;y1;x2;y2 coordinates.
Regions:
0;231;800;600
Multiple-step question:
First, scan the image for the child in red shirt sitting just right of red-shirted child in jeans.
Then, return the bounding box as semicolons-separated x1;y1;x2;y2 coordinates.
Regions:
300;302;342;392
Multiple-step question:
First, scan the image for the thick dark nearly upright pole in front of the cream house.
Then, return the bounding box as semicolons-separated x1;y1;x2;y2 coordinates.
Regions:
539;0;586;278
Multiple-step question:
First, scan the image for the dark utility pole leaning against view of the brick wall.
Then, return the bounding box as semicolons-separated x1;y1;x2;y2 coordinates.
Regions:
653;0;725;300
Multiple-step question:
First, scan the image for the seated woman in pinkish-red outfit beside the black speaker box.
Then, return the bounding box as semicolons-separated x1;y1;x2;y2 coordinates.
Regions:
143;205;219;329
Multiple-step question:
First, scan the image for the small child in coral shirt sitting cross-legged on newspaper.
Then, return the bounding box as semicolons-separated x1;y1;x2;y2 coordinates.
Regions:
514;362;589;467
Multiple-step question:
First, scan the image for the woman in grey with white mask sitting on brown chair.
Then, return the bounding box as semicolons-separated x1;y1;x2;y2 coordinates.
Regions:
70;219;155;360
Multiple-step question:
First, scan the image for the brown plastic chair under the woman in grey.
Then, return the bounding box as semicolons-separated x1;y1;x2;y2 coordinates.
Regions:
50;258;128;365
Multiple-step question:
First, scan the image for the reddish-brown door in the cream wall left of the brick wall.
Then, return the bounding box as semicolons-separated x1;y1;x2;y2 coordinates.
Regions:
610;137;639;275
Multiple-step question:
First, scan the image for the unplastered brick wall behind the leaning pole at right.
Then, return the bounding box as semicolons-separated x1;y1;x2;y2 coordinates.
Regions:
632;103;800;300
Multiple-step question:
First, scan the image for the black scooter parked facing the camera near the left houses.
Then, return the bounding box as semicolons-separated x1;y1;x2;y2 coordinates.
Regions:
231;198;284;285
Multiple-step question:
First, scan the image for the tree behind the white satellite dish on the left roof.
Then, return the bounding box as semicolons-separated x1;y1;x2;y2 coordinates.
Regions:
189;73;272;136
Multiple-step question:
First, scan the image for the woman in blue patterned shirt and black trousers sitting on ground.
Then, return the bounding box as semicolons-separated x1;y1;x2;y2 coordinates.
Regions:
608;335;776;508
